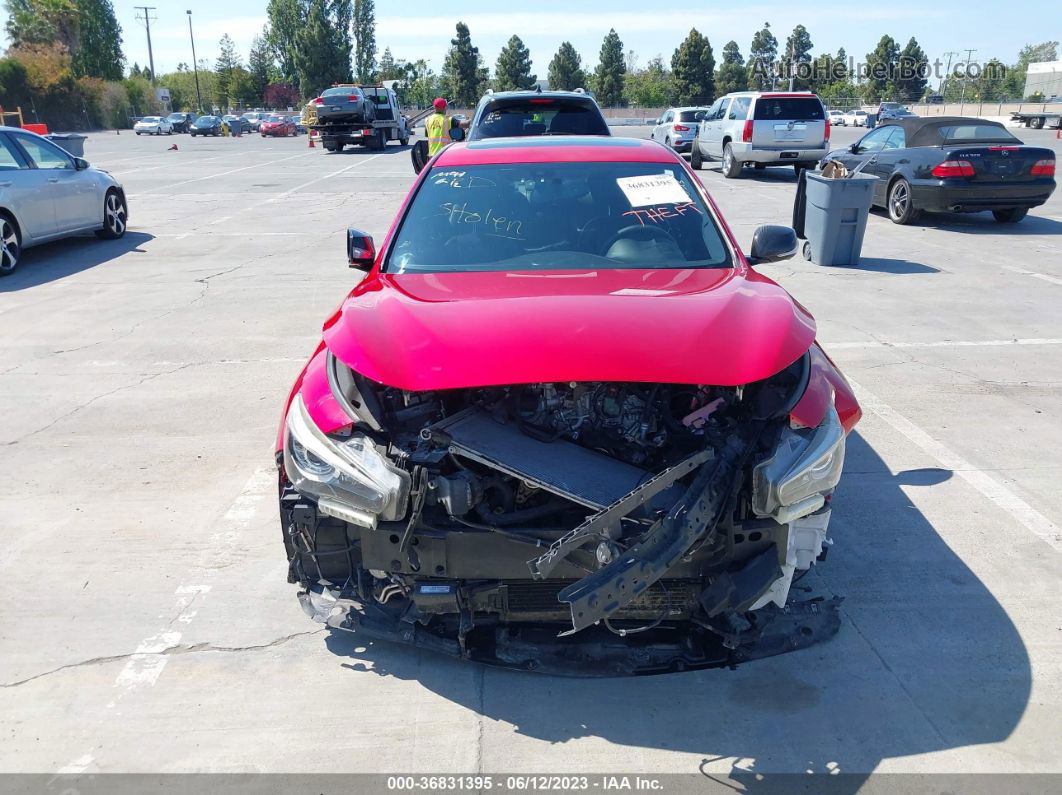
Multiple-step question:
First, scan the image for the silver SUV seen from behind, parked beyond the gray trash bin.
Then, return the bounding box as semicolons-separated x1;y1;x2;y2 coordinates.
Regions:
689;91;829;179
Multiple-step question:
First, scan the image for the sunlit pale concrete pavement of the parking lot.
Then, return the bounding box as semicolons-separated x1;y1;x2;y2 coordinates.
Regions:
0;128;1062;776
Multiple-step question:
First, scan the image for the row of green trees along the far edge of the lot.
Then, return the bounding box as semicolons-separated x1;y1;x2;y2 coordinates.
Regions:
0;0;1058;128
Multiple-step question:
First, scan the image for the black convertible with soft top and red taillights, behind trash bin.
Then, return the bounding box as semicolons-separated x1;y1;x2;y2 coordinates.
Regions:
826;116;1055;224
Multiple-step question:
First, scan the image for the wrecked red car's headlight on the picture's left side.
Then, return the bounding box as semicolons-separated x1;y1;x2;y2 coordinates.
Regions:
284;395;410;521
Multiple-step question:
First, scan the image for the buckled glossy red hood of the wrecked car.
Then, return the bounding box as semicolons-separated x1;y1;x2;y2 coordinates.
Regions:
324;269;815;391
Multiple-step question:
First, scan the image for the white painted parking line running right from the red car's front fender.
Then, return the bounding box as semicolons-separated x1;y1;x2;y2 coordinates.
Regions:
849;379;1062;552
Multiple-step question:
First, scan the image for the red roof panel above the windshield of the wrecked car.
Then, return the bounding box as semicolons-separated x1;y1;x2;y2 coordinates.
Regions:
435;135;678;168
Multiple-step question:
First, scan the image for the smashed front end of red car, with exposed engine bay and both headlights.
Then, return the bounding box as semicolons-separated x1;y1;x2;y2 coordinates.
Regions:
280;355;844;675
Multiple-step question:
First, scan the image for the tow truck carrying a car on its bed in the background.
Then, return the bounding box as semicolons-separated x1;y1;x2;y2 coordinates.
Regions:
303;84;431;152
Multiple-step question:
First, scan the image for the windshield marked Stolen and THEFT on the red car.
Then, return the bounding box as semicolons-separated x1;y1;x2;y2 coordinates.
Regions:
384;162;731;273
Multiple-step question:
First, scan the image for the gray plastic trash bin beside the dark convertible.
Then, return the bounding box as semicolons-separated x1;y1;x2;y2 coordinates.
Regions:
804;172;877;265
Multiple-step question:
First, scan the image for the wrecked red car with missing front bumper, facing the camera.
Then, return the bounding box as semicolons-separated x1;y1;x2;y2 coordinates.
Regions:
276;136;860;676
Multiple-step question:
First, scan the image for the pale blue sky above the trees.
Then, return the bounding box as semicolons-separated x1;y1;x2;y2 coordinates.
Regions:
101;0;1062;77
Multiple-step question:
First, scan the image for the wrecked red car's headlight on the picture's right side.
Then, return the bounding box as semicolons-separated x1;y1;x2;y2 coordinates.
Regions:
752;405;844;516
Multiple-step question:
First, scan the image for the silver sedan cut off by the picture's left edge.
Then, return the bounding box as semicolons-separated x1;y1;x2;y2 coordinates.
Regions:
0;126;129;276
